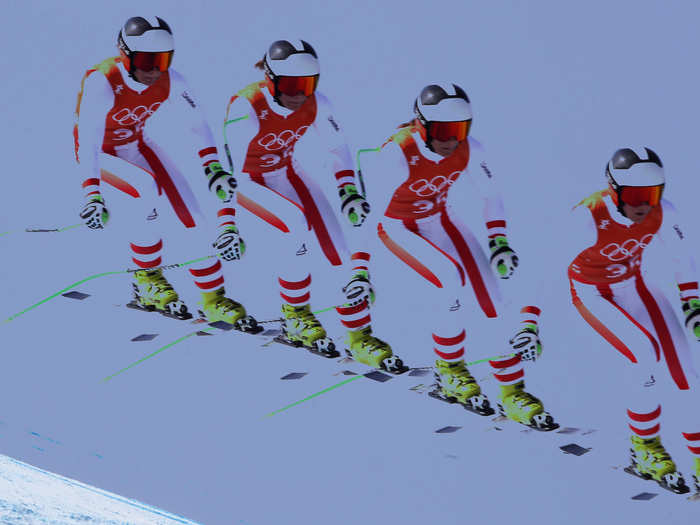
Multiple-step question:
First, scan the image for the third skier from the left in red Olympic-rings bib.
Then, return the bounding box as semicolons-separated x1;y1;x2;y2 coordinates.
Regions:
367;83;558;430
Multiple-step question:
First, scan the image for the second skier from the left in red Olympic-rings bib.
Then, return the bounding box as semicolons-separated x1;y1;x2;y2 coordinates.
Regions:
225;39;406;373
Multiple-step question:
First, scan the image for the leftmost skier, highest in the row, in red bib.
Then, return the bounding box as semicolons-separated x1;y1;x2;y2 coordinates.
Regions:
74;16;259;331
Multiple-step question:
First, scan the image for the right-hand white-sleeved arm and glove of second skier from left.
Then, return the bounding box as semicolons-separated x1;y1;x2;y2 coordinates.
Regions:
314;92;370;226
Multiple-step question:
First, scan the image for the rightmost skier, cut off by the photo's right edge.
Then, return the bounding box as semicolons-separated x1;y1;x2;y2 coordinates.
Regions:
568;148;700;493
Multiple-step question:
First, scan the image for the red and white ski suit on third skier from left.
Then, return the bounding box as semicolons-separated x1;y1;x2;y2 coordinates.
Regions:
367;126;540;384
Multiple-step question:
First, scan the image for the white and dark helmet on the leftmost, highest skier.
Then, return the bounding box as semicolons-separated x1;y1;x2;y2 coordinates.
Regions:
117;16;175;74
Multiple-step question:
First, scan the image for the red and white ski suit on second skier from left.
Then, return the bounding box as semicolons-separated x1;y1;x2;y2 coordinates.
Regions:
226;81;369;329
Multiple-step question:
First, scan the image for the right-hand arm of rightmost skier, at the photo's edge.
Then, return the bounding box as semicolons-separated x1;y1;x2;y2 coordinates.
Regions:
657;199;700;340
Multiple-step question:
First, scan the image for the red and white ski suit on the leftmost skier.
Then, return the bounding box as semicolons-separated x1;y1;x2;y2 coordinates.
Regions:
74;57;234;291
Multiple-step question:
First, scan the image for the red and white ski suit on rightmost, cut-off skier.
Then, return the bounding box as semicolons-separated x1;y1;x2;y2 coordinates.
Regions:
567;190;700;457
